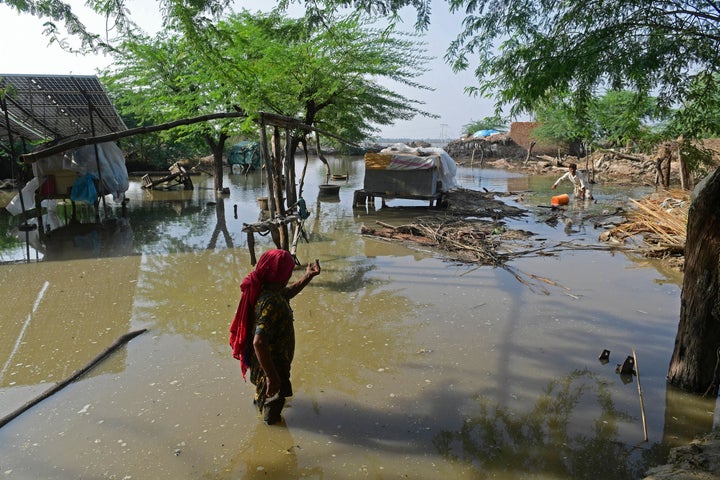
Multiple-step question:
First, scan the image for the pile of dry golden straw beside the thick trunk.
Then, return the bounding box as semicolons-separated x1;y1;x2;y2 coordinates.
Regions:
605;190;690;259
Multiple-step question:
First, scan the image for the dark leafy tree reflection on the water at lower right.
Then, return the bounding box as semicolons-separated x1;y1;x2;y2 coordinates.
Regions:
433;369;663;479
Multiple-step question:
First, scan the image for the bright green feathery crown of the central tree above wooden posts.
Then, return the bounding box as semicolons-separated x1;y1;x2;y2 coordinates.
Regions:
217;12;432;153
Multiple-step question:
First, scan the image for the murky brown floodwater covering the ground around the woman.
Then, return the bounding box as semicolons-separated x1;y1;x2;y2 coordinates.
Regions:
0;158;718;479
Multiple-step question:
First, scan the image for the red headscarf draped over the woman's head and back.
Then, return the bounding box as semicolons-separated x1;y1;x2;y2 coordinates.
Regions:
230;250;295;378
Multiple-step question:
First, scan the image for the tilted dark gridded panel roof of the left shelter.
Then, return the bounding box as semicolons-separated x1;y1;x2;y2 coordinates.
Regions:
0;74;127;141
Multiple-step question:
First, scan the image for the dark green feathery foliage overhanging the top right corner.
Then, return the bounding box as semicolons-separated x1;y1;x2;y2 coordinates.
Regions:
446;0;720;128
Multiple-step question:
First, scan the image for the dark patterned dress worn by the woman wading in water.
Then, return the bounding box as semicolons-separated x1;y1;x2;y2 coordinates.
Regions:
250;289;295;410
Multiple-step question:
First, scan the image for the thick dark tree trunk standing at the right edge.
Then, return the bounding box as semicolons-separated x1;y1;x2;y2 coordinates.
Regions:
667;169;720;396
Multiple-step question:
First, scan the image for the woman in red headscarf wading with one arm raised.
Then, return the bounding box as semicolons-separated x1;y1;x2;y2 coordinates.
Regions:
230;250;320;424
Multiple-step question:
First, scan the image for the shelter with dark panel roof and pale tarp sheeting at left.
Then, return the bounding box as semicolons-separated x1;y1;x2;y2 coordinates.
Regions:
0;74;129;235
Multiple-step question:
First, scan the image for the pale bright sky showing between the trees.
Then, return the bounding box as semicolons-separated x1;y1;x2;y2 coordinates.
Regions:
0;0;493;141
